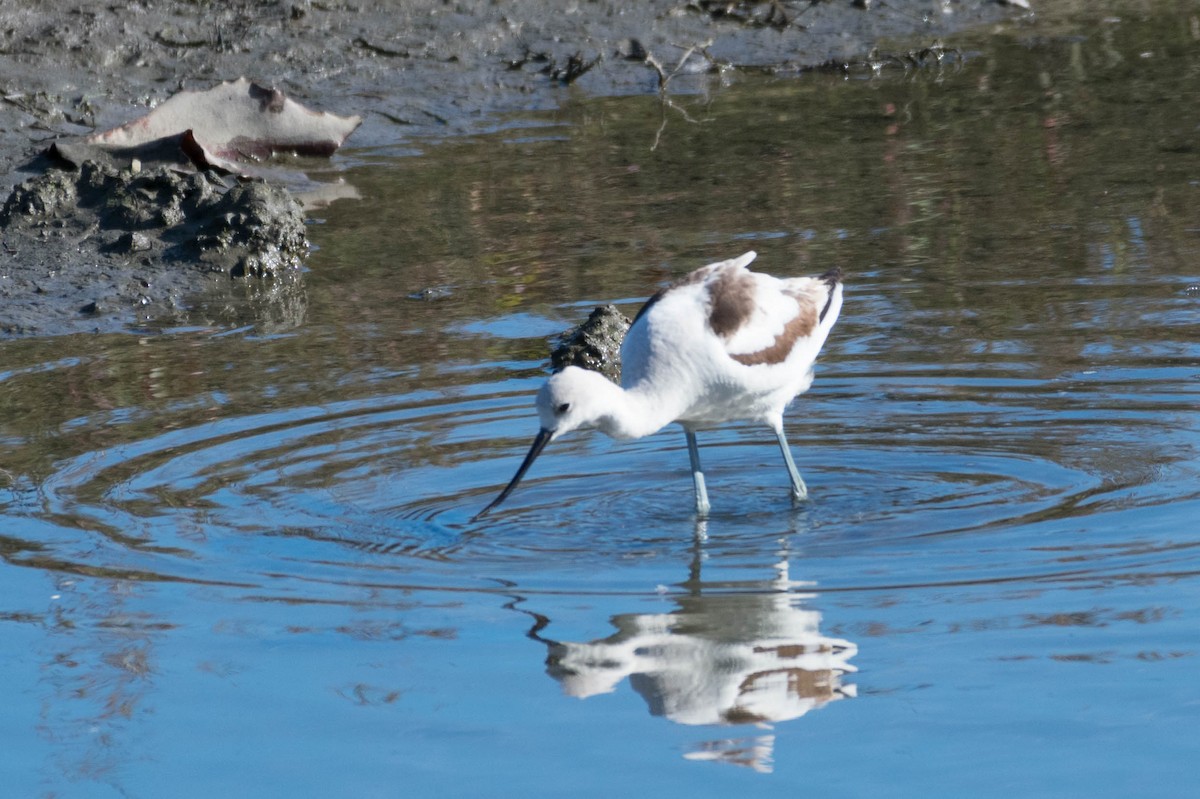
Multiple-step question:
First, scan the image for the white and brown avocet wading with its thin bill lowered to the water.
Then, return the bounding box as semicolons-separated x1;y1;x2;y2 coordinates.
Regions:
475;252;842;518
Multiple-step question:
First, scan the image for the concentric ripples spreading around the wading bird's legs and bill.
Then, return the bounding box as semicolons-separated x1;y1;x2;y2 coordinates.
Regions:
10;343;1200;591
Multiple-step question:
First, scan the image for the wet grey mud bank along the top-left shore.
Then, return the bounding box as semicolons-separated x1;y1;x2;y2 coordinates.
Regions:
0;0;1031;336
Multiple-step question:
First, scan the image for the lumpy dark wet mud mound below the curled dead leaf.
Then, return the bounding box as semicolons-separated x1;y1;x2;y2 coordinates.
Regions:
0;161;308;335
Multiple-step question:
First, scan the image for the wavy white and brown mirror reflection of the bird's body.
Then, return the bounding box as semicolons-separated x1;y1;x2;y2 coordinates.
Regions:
535;561;858;771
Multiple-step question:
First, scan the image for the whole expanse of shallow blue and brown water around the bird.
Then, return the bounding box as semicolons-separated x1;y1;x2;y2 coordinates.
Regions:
0;7;1200;797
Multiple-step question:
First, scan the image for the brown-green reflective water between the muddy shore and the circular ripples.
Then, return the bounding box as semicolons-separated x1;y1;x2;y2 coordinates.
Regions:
0;10;1200;499
